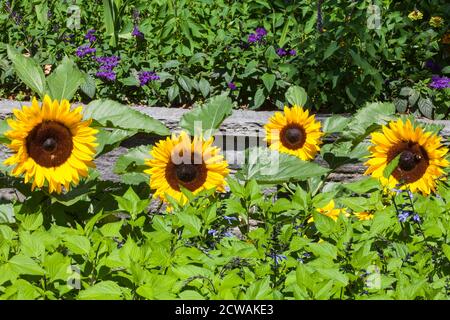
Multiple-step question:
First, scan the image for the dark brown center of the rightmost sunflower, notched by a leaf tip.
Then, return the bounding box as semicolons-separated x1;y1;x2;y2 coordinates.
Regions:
387;141;429;183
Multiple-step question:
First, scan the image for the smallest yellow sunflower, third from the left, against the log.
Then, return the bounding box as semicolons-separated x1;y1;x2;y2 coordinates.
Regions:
264;105;323;161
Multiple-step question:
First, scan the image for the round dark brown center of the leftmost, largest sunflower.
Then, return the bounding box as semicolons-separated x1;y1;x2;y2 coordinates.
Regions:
26;121;73;168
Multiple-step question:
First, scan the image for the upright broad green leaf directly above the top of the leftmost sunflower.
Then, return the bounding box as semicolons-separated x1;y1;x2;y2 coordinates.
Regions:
47;57;85;101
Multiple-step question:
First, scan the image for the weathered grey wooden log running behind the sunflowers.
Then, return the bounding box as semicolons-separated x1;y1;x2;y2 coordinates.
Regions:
0;100;450;182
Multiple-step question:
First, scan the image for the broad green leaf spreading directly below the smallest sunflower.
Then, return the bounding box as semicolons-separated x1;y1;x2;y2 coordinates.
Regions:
241;148;329;184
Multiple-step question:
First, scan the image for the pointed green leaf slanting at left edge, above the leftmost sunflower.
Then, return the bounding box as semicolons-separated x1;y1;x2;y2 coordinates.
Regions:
7;45;45;98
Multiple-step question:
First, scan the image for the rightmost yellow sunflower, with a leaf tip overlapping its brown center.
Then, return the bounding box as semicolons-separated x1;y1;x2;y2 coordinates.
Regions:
365;119;449;195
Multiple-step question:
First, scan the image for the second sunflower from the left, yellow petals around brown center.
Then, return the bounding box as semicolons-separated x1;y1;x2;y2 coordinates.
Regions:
144;132;229;204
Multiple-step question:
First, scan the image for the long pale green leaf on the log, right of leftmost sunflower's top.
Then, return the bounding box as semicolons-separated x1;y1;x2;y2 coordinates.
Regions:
84;100;170;136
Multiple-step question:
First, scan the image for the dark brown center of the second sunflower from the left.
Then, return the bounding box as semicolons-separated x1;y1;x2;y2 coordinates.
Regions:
166;154;208;192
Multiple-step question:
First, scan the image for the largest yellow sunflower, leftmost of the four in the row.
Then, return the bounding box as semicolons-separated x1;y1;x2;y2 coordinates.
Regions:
4;96;98;193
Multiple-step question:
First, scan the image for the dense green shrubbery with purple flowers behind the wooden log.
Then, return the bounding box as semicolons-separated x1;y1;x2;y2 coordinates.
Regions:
0;0;450;118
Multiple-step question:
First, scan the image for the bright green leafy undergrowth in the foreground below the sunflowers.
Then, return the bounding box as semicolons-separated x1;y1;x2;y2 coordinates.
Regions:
0;178;450;299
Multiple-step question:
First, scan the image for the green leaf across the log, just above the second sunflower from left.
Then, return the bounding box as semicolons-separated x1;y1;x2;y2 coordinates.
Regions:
180;95;233;138
